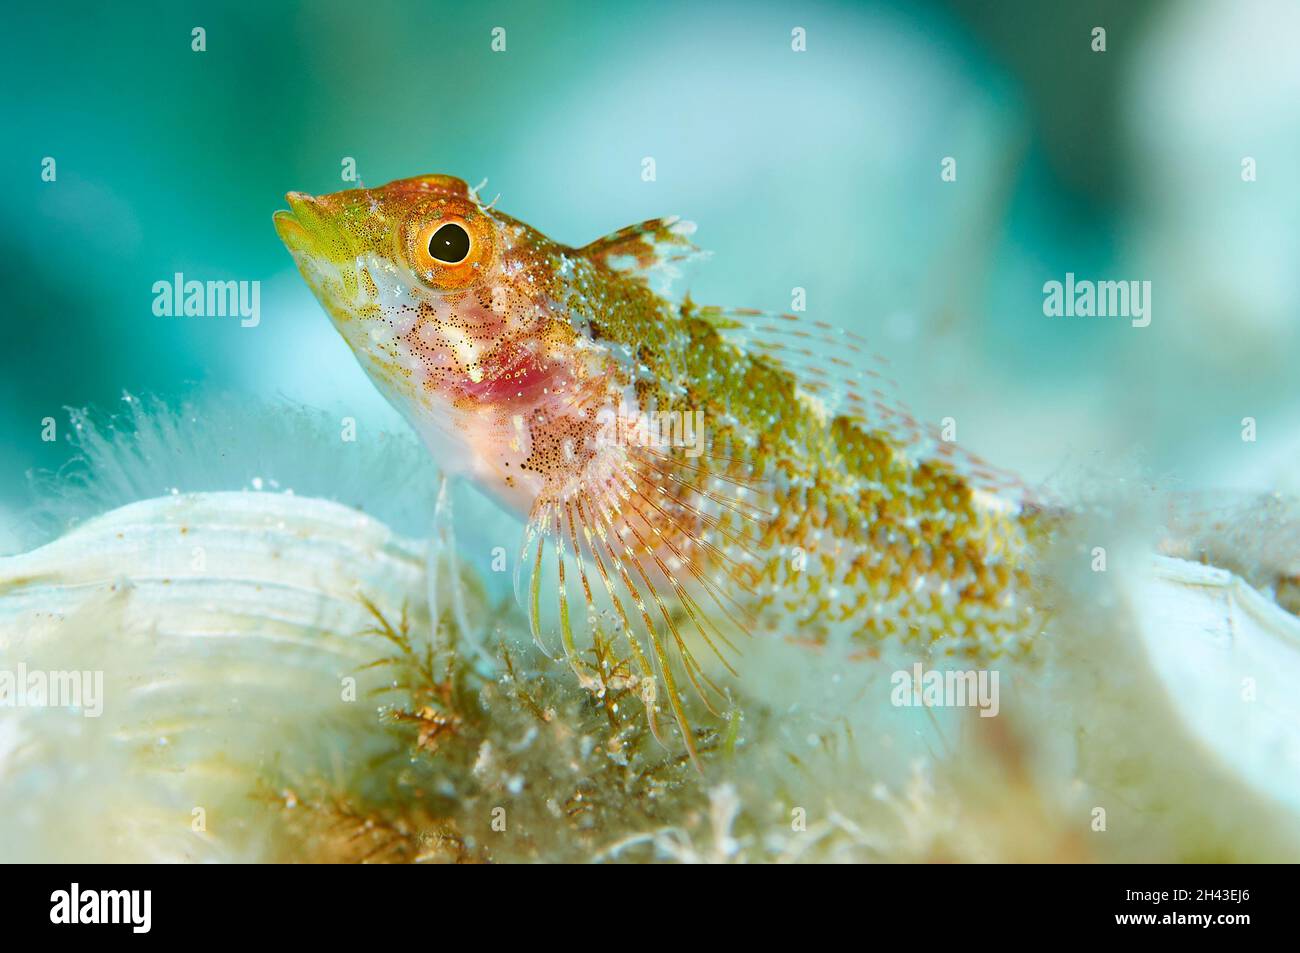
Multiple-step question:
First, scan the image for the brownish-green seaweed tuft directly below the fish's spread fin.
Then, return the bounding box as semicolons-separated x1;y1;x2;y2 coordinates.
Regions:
263;597;725;863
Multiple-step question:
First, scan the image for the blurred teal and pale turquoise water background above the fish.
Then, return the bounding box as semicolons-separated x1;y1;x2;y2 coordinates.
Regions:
0;0;1300;549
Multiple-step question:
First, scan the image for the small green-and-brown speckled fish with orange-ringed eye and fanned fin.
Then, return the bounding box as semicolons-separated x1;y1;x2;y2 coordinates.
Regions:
274;174;1050;758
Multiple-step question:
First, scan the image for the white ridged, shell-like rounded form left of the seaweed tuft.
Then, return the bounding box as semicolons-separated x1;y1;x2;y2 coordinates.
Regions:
0;493;425;861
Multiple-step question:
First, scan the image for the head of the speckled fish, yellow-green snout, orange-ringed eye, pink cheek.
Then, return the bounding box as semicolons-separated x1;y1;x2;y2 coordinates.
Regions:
274;176;631;511
